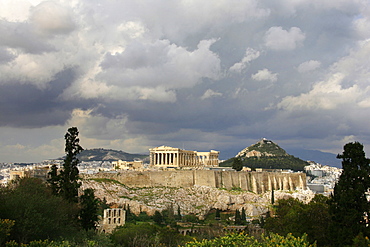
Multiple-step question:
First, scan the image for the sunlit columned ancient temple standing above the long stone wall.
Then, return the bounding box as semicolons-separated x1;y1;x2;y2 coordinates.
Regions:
149;146;220;168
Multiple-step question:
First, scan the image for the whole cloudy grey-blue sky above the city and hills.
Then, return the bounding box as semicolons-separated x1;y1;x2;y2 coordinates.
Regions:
0;0;370;162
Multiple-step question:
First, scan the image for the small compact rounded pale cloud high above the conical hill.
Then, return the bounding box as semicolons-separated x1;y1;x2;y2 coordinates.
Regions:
265;27;306;51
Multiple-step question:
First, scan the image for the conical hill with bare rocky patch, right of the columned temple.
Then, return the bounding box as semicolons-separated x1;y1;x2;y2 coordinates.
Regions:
220;138;308;171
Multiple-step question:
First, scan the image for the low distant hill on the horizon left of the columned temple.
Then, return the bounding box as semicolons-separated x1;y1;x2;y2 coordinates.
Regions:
77;148;149;161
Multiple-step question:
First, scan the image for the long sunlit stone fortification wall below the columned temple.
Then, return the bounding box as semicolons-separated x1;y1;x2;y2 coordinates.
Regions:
82;170;306;193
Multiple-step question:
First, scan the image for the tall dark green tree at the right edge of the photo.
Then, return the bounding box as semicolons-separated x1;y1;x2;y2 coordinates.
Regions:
329;142;370;246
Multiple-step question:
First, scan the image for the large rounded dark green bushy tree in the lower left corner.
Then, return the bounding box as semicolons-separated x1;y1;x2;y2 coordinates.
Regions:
0;178;78;243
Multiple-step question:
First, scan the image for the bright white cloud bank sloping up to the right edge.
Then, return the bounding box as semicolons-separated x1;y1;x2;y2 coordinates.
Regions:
277;40;370;111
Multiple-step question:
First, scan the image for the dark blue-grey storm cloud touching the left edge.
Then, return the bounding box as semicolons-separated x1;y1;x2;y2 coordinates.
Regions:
0;69;74;128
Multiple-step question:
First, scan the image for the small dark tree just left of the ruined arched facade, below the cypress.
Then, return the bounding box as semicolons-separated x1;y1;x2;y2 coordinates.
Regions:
80;188;99;230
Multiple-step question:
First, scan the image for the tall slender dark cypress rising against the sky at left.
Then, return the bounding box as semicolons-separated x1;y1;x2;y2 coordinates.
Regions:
59;127;83;202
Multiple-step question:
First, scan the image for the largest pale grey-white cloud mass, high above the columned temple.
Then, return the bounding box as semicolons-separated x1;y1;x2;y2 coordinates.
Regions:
91;39;221;102
